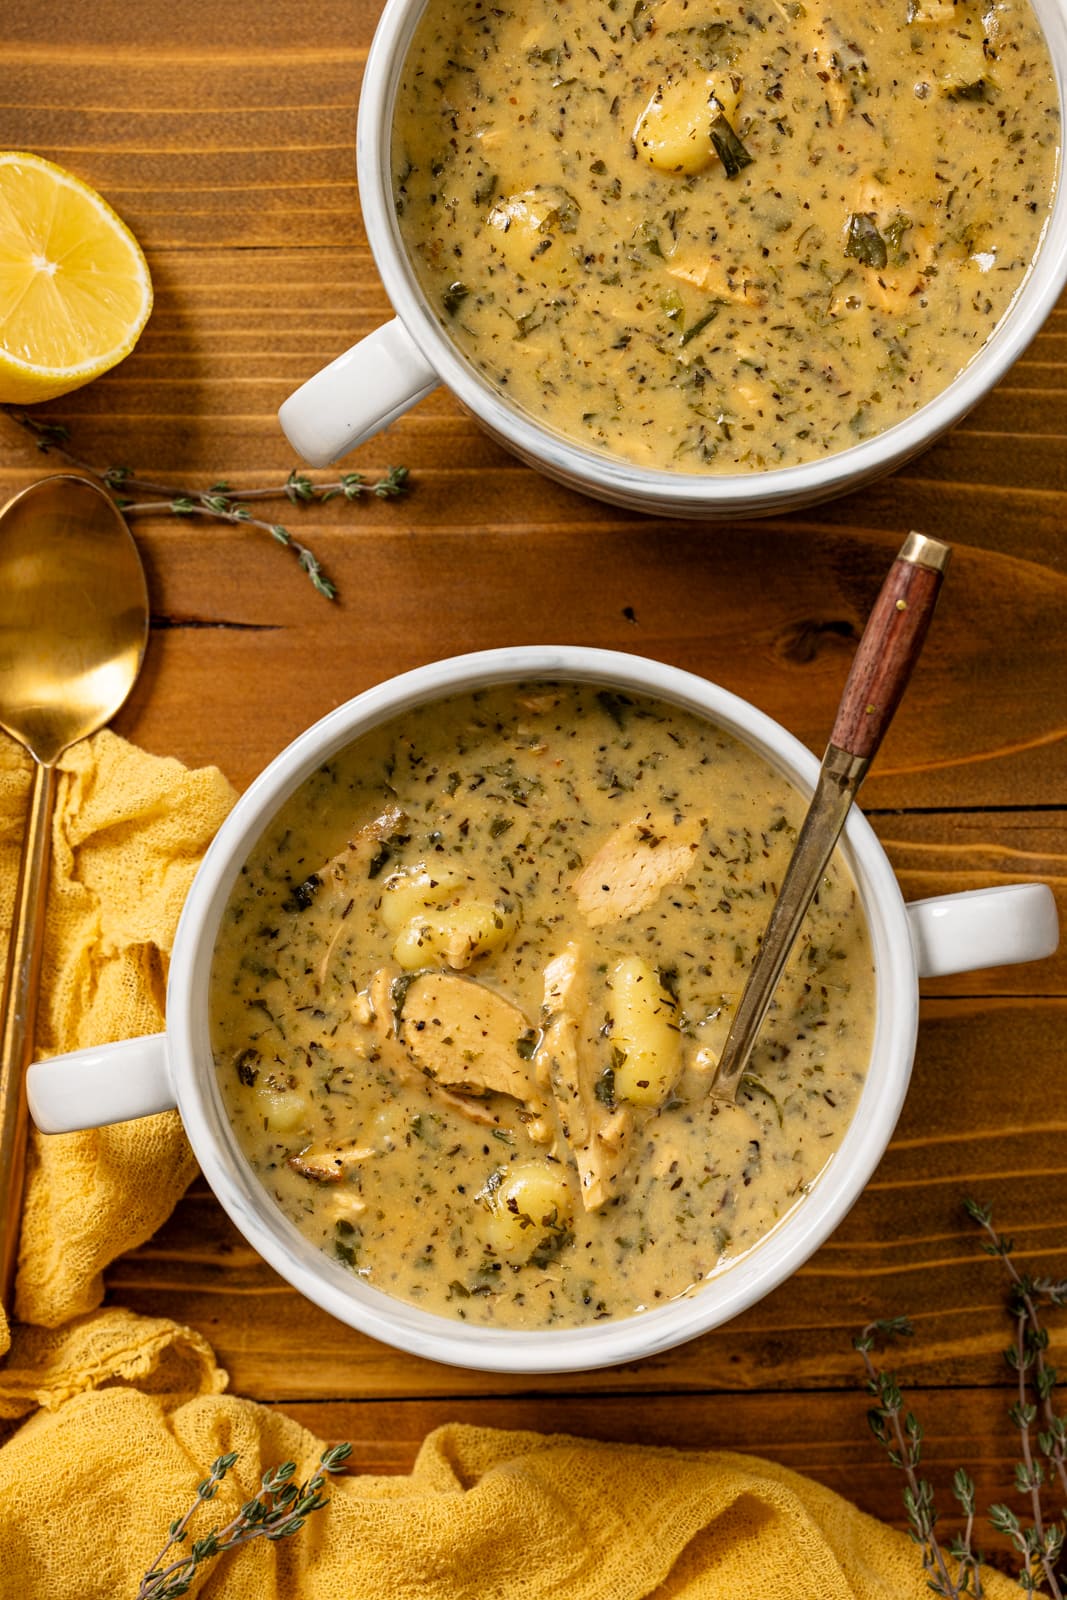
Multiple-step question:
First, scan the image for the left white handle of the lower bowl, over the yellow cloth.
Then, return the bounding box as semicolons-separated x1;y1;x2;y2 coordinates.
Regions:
26;1034;178;1133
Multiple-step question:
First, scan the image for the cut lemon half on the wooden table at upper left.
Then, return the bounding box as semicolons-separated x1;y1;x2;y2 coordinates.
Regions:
0;150;152;405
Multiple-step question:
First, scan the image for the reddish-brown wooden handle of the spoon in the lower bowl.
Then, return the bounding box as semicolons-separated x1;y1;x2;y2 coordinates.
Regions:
830;533;950;762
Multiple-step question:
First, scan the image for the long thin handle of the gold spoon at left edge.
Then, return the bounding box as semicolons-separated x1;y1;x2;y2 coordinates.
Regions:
0;762;56;1315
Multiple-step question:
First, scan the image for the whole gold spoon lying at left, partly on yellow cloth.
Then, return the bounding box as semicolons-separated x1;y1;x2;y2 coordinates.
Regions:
0;472;149;1310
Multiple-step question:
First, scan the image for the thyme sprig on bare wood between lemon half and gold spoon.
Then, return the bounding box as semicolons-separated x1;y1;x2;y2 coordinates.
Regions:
5;408;408;600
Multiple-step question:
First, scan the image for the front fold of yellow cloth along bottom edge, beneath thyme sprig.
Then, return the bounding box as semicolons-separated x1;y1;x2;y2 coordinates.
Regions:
0;1389;1019;1600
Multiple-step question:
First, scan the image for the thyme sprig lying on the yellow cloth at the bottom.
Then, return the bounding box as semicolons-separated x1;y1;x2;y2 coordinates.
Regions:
136;1443;352;1600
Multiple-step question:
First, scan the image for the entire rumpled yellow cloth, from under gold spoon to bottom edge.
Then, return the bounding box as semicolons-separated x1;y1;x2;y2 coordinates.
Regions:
0;733;1017;1600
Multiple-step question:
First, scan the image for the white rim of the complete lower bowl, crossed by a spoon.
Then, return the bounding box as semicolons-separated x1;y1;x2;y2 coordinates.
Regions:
166;645;918;1374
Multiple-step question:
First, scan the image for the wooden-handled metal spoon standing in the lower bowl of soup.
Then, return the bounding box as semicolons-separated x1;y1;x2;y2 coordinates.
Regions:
712;533;950;1101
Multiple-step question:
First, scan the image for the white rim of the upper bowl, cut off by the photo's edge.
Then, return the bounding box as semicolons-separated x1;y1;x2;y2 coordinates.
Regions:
357;0;1067;515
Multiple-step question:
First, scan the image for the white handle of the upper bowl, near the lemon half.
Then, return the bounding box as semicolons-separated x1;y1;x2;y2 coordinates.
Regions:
278;317;438;467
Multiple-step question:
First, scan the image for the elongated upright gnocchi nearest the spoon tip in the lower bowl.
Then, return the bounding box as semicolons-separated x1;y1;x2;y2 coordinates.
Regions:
608;955;681;1106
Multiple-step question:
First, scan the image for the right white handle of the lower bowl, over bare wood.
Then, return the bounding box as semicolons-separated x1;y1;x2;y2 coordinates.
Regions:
907;883;1059;978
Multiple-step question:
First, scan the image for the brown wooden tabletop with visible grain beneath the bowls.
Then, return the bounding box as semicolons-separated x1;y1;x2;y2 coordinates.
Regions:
0;0;1067;1542
